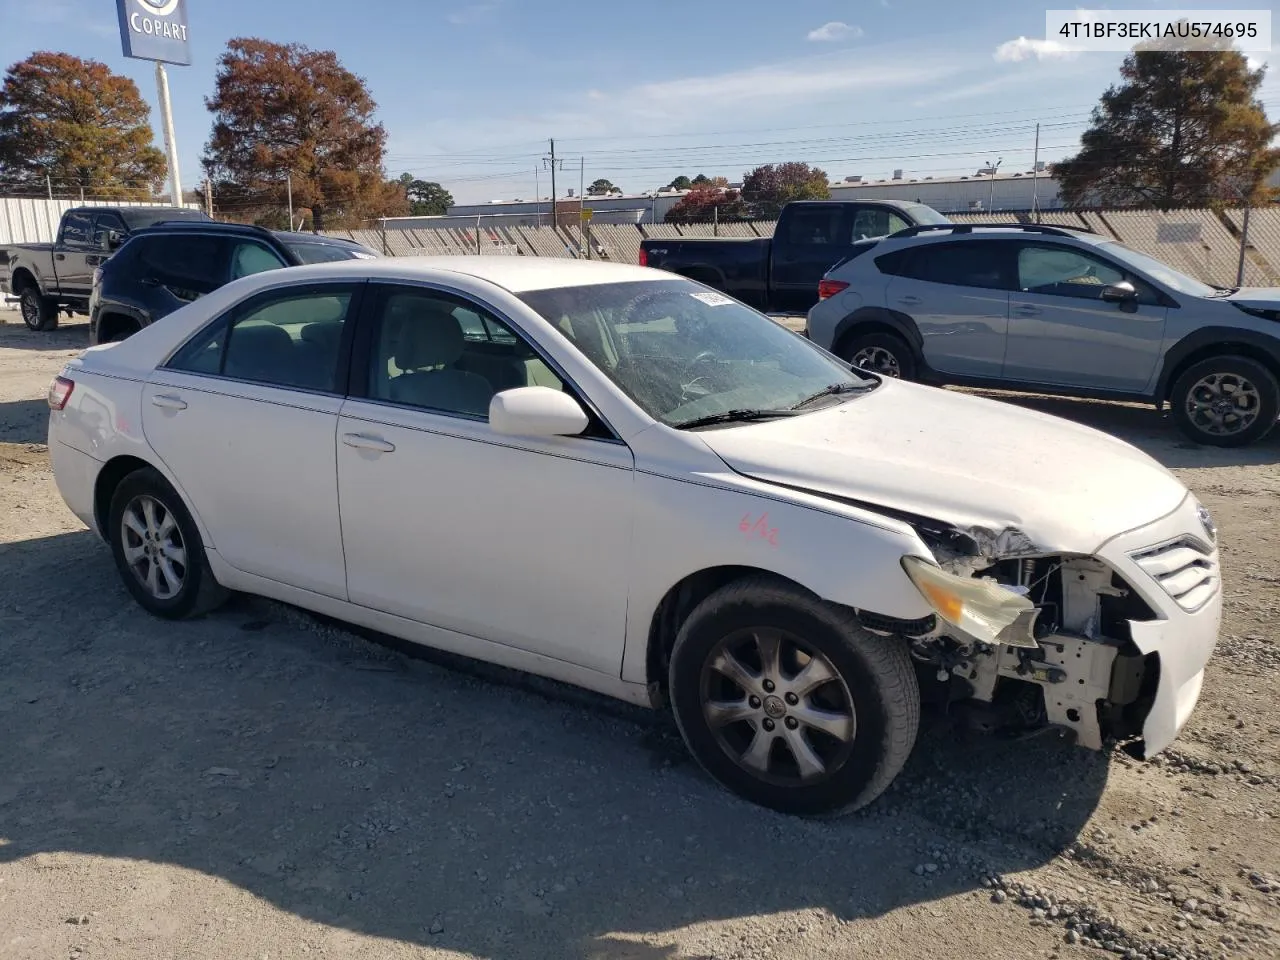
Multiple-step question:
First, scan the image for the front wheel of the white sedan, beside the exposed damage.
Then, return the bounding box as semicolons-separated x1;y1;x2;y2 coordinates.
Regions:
669;576;920;817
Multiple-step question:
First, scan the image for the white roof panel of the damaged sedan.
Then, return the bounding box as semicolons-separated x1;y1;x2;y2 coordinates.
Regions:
266;256;682;293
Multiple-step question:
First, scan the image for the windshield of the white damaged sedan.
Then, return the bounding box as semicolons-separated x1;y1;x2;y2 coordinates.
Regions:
521;278;876;426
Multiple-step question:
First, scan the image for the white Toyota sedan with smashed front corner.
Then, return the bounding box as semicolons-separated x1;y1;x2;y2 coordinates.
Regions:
49;257;1221;815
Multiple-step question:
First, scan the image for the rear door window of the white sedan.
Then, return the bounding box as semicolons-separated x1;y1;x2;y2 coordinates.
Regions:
168;284;355;393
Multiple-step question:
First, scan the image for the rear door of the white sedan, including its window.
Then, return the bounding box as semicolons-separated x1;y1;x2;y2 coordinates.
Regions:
142;283;362;599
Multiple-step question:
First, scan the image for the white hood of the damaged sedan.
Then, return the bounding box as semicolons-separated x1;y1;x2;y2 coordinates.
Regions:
699;380;1187;556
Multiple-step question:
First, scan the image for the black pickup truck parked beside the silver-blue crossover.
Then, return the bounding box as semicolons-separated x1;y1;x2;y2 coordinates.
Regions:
640;200;950;314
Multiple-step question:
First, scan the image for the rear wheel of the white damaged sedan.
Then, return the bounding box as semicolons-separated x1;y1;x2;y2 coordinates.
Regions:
109;467;228;620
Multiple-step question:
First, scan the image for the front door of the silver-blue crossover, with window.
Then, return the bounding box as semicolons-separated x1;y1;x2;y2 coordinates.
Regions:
1004;242;1169;393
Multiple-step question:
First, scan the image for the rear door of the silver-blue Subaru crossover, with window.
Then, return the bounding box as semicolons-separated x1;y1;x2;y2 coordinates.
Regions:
876;238;1012;378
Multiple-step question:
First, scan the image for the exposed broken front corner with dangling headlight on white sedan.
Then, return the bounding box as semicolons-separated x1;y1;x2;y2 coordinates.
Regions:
865;521;1158;750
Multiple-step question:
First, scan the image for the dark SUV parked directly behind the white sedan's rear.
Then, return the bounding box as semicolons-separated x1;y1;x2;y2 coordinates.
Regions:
90;221;378;344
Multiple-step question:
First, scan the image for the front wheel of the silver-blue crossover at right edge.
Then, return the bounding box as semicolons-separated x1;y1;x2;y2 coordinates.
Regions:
1169;355;1280;447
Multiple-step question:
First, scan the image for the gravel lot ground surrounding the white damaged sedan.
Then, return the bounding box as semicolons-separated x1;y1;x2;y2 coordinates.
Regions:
0;311;1280;960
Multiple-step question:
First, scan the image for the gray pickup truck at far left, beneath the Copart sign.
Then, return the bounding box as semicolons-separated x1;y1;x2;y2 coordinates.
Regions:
0;206;210;330
